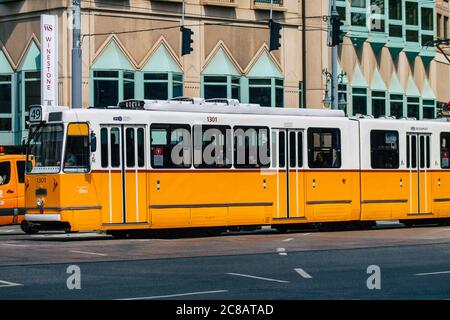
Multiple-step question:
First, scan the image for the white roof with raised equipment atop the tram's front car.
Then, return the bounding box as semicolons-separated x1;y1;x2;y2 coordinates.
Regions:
109;98;345;117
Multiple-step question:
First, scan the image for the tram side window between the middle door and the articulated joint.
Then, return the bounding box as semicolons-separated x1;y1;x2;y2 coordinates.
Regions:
308;128;341;168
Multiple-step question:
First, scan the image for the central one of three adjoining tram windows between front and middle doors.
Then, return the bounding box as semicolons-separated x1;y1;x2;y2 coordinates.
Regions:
194;125;232;169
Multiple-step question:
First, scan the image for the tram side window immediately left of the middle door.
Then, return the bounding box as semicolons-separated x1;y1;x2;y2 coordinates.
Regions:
234;126;270;168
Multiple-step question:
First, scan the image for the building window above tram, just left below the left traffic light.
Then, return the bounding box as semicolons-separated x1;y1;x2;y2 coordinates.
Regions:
144;73;183;100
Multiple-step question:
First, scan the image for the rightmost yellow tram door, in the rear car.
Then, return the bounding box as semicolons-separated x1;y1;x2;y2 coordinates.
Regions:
406;133;432;215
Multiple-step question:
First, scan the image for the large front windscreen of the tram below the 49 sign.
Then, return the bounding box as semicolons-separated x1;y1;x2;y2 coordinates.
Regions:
27;124;64;173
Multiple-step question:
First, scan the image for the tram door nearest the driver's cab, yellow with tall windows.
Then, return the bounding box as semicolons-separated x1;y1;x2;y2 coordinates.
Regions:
109;125;147;224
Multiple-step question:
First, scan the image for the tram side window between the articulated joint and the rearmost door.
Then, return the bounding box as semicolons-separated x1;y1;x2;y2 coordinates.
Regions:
370;130;399;169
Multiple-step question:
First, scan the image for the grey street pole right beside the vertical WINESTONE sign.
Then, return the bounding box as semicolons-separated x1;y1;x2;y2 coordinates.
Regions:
72;0;83;109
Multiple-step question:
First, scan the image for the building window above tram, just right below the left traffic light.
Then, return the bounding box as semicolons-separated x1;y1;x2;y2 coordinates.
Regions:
203;76;241;100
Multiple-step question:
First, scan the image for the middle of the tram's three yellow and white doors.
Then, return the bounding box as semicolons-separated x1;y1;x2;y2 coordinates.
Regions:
272;129;305;219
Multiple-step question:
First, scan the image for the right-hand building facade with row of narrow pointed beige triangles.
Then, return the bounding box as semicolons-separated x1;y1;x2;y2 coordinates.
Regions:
326;0;450;119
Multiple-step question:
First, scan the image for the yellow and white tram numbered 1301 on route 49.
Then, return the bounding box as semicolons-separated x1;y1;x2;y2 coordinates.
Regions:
22;98;450;236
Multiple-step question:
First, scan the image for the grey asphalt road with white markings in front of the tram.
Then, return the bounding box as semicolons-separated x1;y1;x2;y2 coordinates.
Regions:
0;222;450;300
